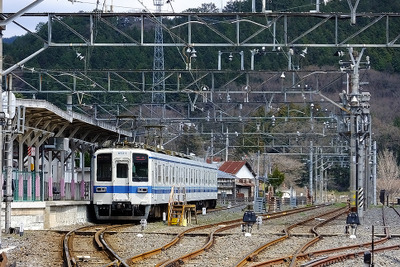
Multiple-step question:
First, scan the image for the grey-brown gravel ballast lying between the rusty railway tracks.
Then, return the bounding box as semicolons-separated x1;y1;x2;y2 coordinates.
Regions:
1;207;400;266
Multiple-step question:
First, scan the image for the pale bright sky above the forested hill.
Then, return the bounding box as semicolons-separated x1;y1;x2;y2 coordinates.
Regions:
0;0;227;38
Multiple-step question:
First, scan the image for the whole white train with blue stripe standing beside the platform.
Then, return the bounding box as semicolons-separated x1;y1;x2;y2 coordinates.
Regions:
93;147;217;220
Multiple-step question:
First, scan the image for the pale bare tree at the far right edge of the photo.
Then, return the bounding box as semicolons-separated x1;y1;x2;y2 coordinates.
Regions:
377;149;400;203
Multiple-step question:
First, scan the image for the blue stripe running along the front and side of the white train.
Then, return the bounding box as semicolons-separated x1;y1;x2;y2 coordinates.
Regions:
93;185;217;194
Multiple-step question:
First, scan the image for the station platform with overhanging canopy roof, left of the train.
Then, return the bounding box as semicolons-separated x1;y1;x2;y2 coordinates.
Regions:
0;97;132;230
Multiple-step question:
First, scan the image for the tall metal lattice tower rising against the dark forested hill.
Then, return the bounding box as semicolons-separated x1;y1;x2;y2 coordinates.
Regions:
151;0;165;103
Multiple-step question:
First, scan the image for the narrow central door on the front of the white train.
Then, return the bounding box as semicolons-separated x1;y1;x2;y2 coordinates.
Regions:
113;159;130;201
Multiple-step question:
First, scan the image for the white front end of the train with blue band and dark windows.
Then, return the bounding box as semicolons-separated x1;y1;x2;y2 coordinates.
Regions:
93;149;151;220
